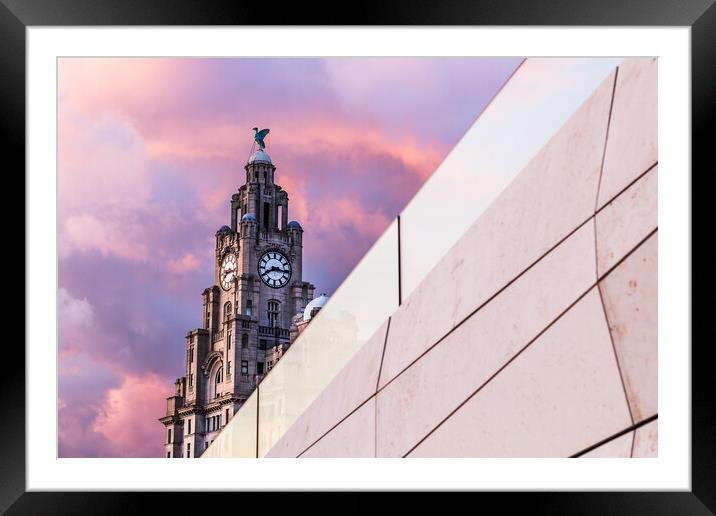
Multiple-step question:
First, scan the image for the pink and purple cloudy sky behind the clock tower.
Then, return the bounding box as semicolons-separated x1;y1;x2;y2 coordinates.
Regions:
57;58;521;457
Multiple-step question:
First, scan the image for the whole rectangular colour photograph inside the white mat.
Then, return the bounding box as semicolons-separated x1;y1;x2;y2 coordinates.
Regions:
57;57;658;458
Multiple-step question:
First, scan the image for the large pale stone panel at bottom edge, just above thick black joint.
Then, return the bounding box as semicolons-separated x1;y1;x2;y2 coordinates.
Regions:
409;288;631;457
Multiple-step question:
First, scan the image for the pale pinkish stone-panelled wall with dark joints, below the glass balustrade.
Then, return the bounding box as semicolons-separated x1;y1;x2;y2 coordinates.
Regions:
260;59;658;457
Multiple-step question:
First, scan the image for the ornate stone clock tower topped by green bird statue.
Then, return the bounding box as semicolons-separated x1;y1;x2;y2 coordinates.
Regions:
159;129;326;458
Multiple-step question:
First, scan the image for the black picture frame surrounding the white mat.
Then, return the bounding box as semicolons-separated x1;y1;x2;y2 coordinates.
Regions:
0;0;716;515
